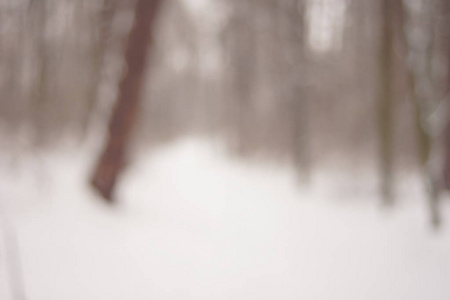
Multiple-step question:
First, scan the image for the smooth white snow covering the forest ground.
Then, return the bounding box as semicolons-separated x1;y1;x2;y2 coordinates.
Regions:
0;138;450;300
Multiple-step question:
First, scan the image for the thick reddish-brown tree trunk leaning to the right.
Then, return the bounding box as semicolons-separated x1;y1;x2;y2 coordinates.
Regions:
91;0;162;202
